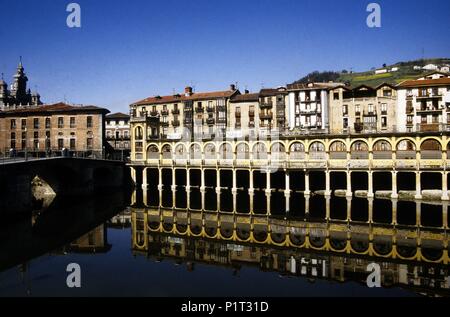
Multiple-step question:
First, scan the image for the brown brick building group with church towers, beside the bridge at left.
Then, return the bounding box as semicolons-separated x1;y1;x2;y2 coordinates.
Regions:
0;62;130;159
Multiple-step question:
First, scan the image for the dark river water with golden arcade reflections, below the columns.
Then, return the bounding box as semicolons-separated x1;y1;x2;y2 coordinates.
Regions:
0;186;450;297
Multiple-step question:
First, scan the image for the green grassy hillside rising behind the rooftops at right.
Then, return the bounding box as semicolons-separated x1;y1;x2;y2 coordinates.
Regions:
295;58;450;86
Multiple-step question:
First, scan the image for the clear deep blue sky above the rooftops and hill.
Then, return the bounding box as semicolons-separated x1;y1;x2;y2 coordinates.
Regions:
0;0;450;111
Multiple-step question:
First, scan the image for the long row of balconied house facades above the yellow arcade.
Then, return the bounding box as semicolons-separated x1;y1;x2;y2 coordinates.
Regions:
130;72;450;140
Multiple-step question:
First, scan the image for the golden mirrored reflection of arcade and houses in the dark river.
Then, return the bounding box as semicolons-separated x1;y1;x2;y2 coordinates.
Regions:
130;186;450;296
